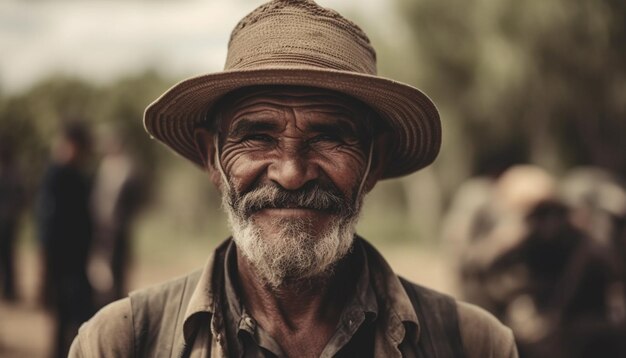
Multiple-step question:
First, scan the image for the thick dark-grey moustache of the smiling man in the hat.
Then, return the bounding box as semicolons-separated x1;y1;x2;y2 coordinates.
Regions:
231;184;353;217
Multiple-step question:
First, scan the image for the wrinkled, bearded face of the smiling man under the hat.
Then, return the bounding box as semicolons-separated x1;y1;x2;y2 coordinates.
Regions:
214;89;371;287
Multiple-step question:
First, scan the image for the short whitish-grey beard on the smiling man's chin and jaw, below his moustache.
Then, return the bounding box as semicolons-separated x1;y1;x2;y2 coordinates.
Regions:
222;185;363;289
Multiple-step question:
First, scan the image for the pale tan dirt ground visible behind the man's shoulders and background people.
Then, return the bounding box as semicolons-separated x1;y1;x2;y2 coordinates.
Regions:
0;245;455;358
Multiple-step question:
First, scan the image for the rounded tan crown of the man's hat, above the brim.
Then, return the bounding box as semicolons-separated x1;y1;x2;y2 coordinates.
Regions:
224;0;376;75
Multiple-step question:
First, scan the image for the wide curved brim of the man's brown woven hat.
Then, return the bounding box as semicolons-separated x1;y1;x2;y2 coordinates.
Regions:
144;68;441;179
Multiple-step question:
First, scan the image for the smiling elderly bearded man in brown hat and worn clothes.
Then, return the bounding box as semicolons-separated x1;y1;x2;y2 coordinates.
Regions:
72;0;517;358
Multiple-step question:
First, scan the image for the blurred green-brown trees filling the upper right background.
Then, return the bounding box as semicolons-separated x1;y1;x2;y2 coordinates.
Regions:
398;0;626;188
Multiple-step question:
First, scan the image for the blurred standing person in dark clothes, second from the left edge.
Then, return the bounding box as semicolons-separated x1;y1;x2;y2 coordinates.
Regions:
37;122;94;357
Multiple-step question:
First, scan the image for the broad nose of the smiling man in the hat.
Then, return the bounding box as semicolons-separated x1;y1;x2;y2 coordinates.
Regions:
267;150;319;190
